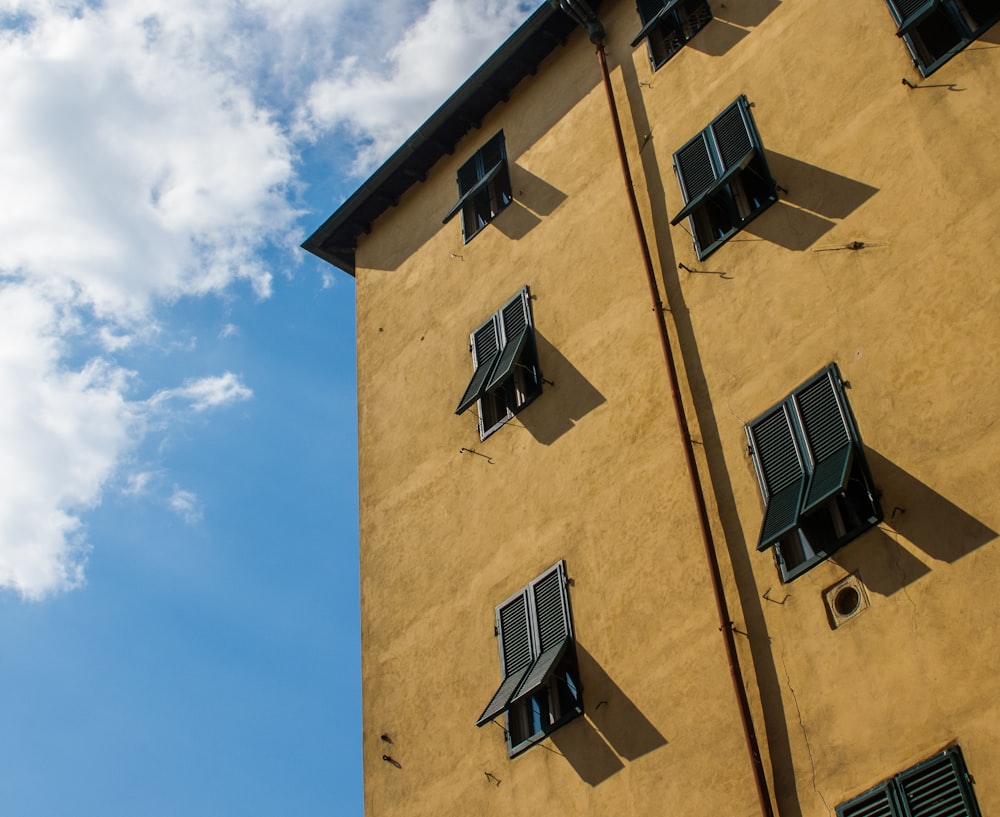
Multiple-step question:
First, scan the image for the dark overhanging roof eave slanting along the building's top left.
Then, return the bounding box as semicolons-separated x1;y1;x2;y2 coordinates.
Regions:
302;3;574;275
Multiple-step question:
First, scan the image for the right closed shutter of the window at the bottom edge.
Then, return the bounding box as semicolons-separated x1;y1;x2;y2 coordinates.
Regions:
893;746;979;817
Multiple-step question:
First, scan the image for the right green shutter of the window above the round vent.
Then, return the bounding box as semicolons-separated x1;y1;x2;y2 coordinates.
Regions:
791;366;855;513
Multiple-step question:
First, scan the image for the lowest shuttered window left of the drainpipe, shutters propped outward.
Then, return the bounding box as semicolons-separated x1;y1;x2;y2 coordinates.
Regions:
476;561;583;757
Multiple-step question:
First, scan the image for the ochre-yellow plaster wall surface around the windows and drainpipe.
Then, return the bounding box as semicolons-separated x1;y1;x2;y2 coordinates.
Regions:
346;0;1000;817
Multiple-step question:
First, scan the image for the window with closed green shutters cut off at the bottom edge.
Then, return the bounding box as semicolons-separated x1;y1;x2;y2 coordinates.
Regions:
837;746;980;817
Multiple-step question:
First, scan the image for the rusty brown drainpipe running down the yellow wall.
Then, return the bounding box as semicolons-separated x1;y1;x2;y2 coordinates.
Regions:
549;0;774;817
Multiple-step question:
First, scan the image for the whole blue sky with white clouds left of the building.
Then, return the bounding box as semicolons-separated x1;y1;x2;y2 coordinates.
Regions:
0;0;538;817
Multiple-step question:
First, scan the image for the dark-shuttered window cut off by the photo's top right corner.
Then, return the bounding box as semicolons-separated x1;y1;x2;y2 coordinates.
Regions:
886;0;1000;77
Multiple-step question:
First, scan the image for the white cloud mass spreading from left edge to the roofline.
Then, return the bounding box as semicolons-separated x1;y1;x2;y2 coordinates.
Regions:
0;0;530;599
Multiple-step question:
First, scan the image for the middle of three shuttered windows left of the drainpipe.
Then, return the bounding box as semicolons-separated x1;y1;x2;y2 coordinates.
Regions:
455;286;542;440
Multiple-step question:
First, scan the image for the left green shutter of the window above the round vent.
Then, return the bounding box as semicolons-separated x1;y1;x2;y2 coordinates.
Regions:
747;403;806;550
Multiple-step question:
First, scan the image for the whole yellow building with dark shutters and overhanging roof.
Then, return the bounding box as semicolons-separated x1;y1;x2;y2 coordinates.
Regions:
305;0;1000;817
